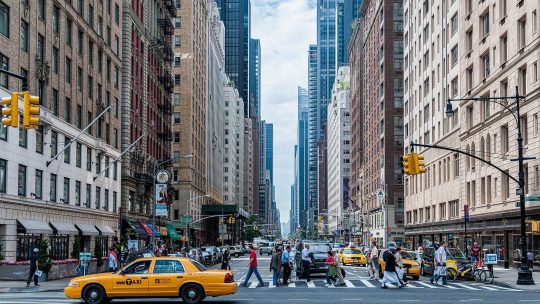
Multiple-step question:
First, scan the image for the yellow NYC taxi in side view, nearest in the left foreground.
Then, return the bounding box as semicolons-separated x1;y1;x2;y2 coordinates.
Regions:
64;257;238;304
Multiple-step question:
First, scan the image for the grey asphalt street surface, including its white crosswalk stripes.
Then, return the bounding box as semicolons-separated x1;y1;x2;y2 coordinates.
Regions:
0;256;540;304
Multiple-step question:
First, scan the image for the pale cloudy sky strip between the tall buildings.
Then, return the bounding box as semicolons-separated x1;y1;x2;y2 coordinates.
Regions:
251;0;317;228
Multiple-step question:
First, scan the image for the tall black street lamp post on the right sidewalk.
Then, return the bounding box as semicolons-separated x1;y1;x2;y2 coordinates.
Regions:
446;86;534;285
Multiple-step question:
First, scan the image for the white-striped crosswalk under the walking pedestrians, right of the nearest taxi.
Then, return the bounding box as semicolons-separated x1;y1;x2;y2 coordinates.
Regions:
239;279;523;291
